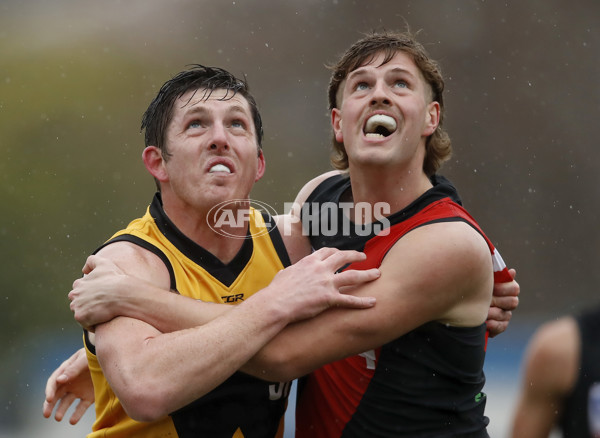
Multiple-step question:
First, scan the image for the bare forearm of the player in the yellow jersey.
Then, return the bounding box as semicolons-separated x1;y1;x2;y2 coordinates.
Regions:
97;288;288;421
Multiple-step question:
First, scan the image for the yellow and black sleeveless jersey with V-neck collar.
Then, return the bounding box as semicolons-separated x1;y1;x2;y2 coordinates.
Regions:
85;194;290;438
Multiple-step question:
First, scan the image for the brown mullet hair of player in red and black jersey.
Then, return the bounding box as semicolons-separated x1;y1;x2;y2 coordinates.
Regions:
328;31;452;176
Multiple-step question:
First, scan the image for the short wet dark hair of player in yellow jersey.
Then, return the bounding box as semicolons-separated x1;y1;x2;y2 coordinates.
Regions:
141;64;263;159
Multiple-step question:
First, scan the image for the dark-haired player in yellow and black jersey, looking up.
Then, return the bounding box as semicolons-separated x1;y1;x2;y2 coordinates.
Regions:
43;65;378;438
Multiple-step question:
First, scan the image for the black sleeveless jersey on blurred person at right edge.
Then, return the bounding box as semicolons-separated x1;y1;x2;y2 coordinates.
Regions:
559;308;600;438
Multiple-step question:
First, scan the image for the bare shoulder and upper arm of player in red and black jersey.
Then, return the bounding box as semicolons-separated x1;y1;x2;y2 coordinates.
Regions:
381;222;493;326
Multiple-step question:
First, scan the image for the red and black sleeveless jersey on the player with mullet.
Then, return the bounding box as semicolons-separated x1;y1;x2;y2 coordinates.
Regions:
296;175;510;438
